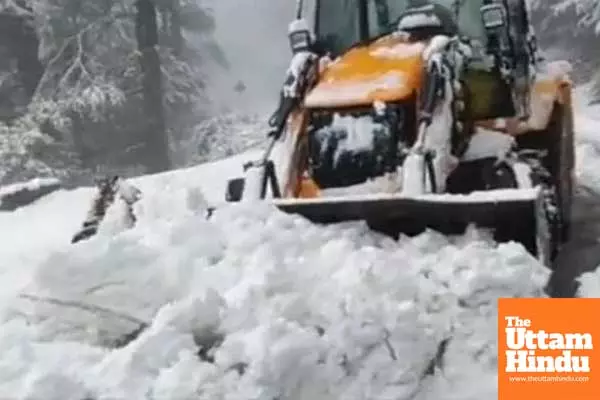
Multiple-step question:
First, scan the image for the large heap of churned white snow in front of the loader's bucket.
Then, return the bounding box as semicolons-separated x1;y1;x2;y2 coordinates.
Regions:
0;200;549;400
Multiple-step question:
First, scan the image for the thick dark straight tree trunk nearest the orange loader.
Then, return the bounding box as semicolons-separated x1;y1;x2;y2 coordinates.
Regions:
136;0;171;173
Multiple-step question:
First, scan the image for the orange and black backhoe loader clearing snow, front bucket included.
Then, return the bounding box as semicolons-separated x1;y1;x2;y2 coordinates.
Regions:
226;0;574;266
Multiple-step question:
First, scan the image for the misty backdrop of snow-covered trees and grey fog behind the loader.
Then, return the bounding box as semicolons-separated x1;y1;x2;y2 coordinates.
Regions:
0;0;600;185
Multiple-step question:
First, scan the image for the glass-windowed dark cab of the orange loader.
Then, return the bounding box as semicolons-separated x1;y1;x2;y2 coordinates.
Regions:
304;0;537;120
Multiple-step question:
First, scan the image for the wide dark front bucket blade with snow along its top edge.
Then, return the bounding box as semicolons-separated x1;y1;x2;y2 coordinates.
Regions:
275;189;550;264
